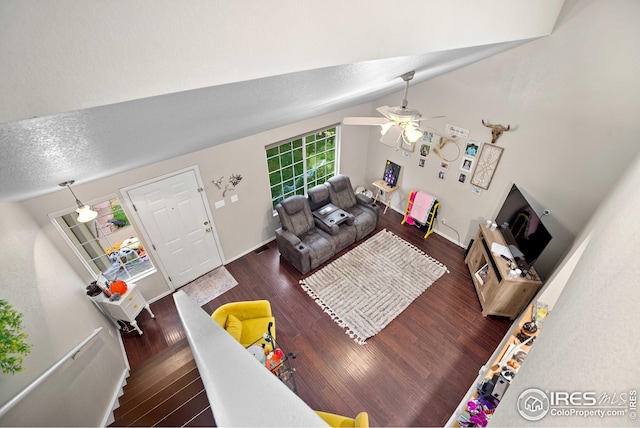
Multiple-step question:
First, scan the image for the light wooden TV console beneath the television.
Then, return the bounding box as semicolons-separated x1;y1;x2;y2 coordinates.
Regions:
464;224;542;320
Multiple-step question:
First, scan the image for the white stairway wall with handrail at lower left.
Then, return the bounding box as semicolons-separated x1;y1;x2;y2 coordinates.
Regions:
0;203;127;426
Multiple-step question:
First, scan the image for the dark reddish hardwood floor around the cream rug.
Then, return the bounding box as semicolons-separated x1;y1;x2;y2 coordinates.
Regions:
115;211;511;426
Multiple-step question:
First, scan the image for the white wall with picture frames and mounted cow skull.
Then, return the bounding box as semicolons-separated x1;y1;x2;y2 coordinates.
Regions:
367;1;640;278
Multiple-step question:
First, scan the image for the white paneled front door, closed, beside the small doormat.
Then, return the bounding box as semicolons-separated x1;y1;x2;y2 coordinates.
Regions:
123;169;222;289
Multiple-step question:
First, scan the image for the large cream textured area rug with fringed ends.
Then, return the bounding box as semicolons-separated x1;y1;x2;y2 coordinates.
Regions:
300;230;448;344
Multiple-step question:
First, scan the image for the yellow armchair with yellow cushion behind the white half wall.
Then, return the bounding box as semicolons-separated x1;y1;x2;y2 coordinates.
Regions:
211;300;276;348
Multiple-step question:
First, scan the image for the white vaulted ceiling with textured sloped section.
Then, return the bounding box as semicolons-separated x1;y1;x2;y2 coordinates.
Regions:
0;0;563;201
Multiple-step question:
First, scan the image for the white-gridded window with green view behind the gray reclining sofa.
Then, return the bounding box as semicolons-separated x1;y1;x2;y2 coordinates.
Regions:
266;126;340;207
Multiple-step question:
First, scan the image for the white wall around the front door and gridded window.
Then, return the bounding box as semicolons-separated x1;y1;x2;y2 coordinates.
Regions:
24;104;371;300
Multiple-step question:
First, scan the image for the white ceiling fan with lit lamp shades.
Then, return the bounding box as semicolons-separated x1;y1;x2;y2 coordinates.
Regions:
342;71;444;150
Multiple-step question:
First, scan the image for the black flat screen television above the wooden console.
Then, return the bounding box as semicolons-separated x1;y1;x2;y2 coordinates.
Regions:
495;184;551;270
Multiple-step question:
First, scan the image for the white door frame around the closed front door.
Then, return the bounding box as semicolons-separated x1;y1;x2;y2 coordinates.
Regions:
120;165;226;292
